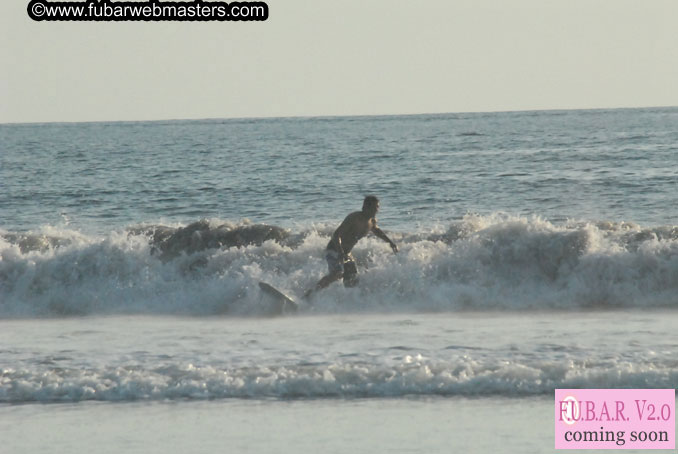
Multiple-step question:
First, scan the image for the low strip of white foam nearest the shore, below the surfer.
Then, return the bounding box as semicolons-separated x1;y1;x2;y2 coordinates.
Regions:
0;354;678;403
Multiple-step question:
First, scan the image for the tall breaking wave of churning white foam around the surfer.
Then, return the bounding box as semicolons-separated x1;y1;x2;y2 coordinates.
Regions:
0;214;678;318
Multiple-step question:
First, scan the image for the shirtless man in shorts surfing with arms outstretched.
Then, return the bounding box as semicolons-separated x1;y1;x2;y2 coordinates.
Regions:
304;195;398;298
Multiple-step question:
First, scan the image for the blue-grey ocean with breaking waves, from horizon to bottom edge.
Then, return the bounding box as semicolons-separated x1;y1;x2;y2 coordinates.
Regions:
0;108;678;454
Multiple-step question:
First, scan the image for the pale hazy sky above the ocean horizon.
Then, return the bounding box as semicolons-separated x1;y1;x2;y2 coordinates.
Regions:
0;0;678;123
